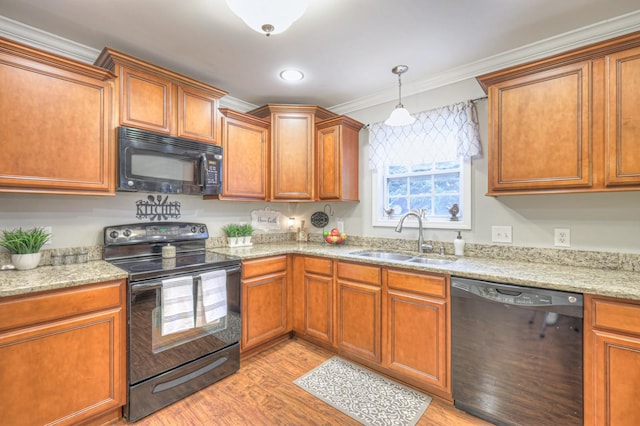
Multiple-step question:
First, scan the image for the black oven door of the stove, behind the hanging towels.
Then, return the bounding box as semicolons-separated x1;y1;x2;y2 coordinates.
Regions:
128;266;241;385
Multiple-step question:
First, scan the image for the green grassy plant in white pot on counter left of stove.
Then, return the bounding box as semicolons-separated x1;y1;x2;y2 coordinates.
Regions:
0;227;51;270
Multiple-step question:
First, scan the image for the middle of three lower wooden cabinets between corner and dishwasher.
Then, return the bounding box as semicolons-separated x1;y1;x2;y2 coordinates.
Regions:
336;262;382;363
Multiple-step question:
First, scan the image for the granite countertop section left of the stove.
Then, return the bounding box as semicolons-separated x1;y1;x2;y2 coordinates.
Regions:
0;260;128;297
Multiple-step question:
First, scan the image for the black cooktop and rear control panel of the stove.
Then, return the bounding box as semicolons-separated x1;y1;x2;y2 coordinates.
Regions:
104;222;240;281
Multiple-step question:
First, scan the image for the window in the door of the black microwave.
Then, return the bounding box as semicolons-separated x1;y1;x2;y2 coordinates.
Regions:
131;150;195;182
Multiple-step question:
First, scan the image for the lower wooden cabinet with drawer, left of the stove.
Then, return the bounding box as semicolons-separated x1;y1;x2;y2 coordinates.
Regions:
0;280;126;425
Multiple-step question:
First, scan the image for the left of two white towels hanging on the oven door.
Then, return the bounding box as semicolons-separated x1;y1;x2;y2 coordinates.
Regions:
162;276;194;336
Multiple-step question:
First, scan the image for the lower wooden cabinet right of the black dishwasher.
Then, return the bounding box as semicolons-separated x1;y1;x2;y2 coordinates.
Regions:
584;295;640;426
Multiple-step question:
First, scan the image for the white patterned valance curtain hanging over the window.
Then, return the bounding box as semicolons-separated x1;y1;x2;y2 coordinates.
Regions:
369;101;482;171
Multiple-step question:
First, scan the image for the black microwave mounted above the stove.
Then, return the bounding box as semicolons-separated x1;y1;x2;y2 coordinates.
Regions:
117;127;222;195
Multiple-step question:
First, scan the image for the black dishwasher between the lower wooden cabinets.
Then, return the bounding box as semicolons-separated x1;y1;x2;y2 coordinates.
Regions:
451;277;583;425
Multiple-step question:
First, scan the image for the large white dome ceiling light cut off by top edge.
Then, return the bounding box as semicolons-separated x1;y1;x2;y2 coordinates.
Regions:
226;0;310;37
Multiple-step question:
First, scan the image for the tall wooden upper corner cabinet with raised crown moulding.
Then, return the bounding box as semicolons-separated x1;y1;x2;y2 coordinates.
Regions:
248;104;336;201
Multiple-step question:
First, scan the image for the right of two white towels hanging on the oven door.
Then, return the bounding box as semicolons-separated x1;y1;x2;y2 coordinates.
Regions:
196;269;227;327
